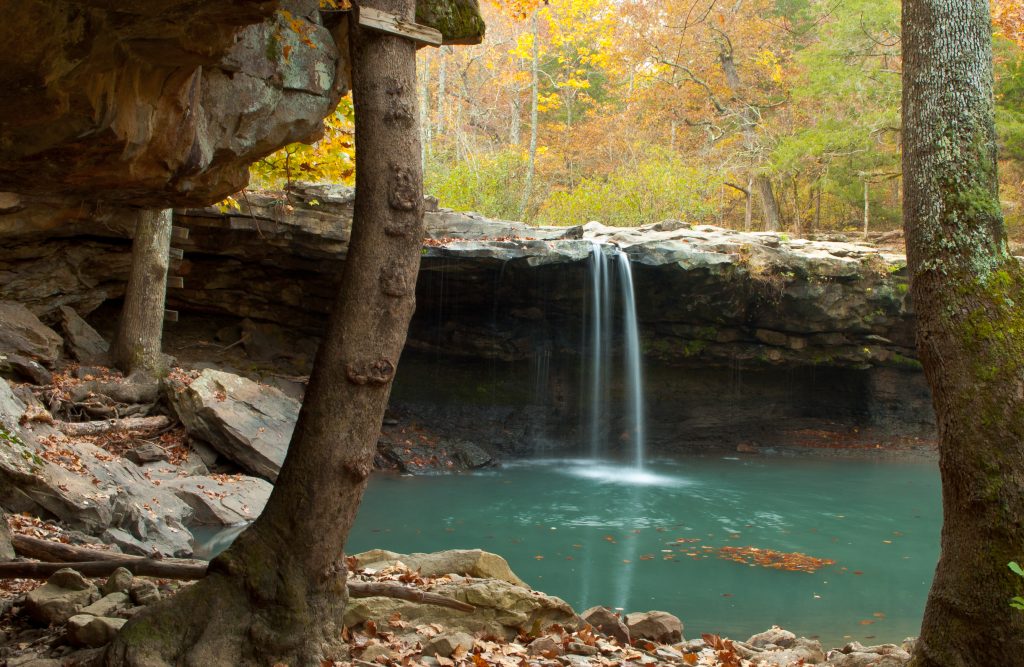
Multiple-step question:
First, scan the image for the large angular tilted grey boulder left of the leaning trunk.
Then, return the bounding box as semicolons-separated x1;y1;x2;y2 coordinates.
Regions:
168;369;300;482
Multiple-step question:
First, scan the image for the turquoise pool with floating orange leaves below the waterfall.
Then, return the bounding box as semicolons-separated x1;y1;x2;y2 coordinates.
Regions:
199;457;941;647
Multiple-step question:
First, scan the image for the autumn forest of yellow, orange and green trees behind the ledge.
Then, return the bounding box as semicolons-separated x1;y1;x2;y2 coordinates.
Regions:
254;0;1024;238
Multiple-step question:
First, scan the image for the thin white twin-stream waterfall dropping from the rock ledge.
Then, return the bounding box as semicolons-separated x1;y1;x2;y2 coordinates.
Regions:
586;242;645;469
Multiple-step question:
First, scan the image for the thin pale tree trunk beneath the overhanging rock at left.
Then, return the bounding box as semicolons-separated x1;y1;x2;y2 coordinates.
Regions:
111;209;171;377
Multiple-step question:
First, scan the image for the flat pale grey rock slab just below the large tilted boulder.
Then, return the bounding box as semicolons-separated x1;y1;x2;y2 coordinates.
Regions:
162;475;273;526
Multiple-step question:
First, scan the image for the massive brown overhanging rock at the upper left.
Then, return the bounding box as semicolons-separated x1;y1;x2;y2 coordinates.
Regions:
0;0;348;209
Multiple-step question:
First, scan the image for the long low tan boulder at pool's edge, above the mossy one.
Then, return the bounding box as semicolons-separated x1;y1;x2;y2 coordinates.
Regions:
352;549;529;588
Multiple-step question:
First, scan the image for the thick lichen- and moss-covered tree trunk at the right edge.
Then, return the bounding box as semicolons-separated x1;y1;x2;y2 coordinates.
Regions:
903;0;1024;667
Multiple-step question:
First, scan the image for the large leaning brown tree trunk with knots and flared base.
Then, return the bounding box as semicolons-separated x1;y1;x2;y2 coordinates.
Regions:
106;0;424;667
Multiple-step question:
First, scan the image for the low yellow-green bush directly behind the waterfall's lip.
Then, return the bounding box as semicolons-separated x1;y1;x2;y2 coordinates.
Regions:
538;152;722;226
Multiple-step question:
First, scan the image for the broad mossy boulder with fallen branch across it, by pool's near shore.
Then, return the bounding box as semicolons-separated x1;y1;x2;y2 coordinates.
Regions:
344;579;582;639
